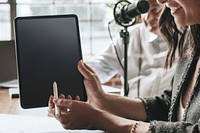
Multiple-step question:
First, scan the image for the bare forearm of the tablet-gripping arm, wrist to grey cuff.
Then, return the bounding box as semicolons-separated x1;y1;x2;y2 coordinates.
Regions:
101;94;147;121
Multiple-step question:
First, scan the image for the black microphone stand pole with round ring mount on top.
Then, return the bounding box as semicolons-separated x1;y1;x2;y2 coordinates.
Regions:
114;0;136;96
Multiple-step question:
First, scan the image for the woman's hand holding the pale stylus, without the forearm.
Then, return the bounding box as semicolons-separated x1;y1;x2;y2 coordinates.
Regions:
53;99;99;129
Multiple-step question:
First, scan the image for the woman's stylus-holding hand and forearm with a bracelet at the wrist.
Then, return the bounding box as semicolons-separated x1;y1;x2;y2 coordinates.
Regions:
49;97;149;133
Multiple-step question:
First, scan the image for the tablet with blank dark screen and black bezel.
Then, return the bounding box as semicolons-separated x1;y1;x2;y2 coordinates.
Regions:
14;14;87;108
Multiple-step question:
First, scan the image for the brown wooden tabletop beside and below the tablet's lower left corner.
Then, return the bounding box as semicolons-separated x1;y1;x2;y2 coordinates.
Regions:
0;88;48;116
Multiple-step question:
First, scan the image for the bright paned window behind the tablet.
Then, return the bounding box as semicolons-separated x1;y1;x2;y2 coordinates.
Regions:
0;0;116;55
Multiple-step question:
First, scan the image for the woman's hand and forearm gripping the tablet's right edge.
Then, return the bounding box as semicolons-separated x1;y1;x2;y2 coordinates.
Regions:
78;61;146;120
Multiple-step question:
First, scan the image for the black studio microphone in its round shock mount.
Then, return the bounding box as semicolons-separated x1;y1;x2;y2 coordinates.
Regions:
114;0;149;26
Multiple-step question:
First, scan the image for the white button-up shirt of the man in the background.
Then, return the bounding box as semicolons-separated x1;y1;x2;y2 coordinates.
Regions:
86;23;175;97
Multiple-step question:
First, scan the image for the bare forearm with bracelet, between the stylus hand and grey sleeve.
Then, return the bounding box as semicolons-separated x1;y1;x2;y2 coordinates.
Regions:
93;110;150;133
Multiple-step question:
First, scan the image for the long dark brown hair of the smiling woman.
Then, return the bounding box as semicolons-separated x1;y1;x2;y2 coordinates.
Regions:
160;7;200;68
